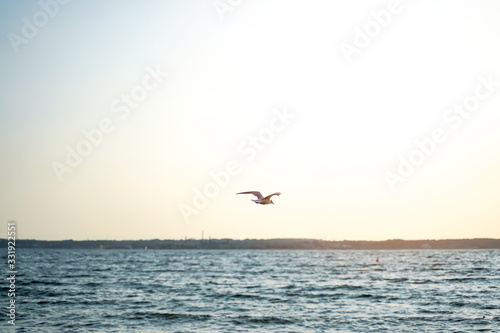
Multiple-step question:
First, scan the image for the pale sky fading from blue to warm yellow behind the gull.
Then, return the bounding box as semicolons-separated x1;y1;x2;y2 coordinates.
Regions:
0;0;500;240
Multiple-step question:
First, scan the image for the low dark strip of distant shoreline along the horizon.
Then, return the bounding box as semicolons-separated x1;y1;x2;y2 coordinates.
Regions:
0;238;500;250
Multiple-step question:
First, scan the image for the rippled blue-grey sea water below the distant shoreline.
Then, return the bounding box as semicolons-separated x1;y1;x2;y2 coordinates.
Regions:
0;249;500;333
